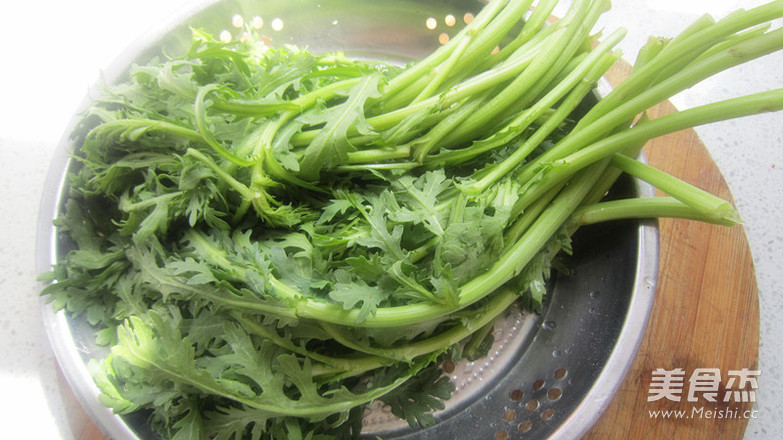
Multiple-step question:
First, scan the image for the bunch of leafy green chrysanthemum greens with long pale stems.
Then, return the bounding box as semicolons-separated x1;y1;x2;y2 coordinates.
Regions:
44;0;783;439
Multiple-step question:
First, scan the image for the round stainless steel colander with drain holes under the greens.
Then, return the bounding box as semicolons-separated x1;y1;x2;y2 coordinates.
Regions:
38;0;658;440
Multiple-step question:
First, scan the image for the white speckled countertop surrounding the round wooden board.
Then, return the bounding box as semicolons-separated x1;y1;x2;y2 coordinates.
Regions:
0;0;783;440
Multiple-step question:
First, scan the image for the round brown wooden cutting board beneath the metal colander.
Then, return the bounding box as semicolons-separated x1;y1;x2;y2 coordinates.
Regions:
53;62;759;440
